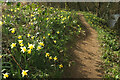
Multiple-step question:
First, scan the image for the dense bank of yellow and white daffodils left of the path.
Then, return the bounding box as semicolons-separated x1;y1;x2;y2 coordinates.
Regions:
1;3;81;79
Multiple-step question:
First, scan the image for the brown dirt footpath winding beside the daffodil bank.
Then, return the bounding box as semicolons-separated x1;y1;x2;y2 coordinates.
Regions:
64;13;102;78
